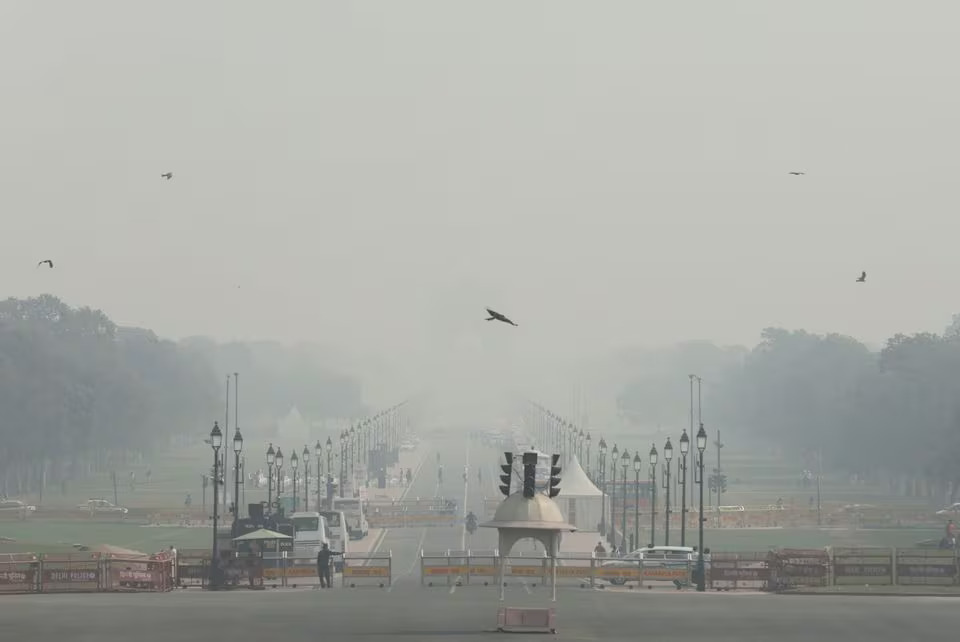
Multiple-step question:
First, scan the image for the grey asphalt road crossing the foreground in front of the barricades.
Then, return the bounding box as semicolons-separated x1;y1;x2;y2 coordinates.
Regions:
0;583;960;642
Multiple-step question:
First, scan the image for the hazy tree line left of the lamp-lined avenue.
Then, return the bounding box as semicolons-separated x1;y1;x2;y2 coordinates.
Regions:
0;295;360;494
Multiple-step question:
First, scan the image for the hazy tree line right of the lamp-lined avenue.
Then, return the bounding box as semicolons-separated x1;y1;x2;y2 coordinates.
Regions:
619;322;960;495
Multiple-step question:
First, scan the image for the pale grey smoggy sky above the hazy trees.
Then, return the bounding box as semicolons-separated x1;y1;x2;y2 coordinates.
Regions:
0;0;960;400
